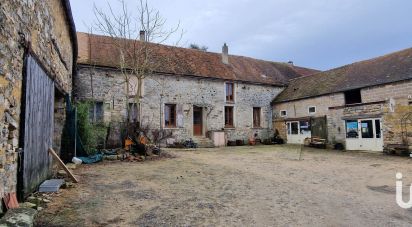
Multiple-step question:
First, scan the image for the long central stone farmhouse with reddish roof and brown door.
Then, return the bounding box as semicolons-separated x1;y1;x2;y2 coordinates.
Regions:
75;33;317;145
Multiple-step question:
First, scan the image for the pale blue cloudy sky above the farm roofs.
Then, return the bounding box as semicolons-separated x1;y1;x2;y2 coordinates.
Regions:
70;0;412;70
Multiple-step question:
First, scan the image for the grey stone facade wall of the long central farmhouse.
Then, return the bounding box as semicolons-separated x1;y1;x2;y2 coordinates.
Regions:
75;66;281;143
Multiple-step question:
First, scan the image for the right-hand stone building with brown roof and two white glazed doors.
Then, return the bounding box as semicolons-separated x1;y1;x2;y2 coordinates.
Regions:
272;49;412;151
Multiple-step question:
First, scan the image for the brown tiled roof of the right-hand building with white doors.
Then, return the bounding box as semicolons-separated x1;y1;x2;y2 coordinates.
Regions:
273;48;412;102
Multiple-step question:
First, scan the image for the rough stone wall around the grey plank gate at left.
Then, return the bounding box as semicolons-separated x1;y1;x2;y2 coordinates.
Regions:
0;0;73;209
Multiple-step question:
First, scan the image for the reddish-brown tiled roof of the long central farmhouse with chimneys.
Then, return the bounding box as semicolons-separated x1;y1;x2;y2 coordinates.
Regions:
77;33;319;85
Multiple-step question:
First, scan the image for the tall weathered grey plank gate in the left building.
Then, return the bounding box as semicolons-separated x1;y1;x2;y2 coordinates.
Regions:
19;55;54;196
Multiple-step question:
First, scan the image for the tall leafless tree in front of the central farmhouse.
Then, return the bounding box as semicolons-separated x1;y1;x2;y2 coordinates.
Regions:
93;0;183;122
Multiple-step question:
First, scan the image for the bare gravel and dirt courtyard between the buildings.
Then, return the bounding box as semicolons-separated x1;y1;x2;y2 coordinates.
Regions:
37;146;412;226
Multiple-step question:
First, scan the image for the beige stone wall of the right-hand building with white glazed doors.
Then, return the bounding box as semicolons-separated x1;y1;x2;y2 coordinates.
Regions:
273;80;412;145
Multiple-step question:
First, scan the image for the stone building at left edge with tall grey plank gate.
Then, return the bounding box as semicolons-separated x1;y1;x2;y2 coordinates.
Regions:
0;0;77;208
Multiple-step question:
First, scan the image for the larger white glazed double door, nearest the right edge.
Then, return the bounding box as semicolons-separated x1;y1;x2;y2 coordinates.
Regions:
346;118;383;151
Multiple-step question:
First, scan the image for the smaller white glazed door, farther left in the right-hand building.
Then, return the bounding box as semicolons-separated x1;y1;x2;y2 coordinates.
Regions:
286;121;311;144
